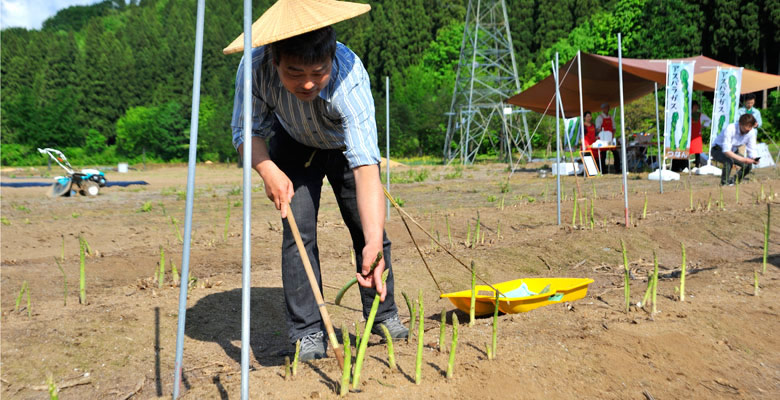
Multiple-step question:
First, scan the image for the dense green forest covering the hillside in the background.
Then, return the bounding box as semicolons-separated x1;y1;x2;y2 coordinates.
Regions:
0;0;780;165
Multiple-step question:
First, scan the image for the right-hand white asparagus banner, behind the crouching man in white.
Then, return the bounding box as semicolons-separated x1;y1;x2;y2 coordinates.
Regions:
710;67;742;142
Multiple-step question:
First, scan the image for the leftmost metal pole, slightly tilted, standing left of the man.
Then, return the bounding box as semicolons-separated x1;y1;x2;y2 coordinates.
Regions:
173;0;206;399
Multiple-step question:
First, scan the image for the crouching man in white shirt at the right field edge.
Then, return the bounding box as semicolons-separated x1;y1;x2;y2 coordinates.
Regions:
712;114;758;186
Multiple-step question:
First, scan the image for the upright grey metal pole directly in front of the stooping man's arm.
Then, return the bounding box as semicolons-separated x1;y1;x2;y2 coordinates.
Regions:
241;0;251;400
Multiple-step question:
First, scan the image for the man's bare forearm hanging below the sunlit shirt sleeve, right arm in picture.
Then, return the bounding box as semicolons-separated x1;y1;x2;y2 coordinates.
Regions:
353;165;385;248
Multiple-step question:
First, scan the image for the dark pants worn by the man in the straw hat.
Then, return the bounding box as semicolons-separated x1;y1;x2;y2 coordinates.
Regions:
269;123;397;343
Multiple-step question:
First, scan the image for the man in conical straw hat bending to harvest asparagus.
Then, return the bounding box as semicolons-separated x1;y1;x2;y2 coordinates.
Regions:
225;0;408;361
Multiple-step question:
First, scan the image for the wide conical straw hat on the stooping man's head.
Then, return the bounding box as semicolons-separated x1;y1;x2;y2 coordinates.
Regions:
222;0;371;54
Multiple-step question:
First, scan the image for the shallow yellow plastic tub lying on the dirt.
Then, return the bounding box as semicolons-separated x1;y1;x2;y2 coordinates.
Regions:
440;278;593;315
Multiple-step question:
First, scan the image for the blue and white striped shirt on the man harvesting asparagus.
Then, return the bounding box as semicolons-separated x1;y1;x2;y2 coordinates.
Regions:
231;43;379;168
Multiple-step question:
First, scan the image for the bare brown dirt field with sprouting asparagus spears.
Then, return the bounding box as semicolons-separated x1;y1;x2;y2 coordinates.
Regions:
0;164;780;399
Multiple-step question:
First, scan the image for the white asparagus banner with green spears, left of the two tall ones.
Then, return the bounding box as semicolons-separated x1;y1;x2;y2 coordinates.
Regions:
664;61;695;160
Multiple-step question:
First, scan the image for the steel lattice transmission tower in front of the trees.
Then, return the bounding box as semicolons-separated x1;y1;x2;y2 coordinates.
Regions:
444;0;532;164
